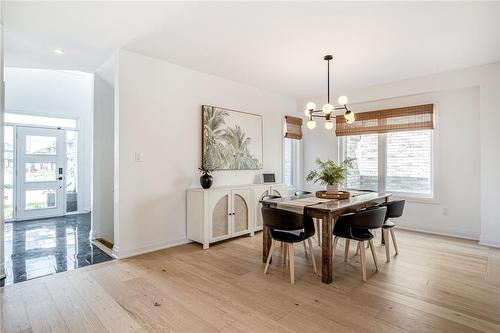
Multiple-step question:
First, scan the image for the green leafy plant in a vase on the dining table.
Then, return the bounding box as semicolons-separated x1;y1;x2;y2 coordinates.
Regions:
306;158;355;193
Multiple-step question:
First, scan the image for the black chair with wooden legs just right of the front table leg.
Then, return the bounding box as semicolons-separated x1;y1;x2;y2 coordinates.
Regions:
332;207;387;281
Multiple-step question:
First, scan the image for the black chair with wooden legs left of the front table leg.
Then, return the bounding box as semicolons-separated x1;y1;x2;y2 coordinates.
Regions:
262;207;318;284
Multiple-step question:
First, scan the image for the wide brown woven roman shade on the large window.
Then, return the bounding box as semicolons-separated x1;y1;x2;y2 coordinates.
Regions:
335;104;434;136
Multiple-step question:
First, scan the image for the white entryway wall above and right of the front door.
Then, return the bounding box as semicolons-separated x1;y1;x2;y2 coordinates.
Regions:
5;68;93;211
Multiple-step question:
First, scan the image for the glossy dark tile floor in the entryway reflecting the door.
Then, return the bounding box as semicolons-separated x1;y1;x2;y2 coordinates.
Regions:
5;214;112;284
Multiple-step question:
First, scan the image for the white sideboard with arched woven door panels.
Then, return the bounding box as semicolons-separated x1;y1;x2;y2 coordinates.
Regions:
187;184;288;249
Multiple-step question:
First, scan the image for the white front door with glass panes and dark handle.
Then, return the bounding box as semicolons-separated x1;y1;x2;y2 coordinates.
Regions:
16;126;66;219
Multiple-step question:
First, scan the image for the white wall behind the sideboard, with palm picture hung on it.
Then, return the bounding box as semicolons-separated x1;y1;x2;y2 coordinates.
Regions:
115;50;295;257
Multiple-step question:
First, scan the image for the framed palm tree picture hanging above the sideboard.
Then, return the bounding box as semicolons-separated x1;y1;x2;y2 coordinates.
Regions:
202;105;263;170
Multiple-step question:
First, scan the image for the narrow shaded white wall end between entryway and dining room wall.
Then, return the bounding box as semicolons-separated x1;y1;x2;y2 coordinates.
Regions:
92;58;115;243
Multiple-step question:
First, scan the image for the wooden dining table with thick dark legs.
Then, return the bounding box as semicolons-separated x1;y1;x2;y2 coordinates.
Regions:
260;192;391;283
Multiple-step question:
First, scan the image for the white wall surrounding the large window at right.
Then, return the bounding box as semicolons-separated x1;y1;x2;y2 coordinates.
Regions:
297;63;500;246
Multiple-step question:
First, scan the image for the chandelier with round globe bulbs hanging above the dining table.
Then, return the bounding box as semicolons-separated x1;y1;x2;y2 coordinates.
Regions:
304;54;355;130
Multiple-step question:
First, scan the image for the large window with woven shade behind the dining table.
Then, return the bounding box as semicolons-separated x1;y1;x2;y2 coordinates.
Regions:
336;104;434;198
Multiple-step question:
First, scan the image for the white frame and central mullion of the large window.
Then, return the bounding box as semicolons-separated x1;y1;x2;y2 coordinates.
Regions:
338;129;438;204
